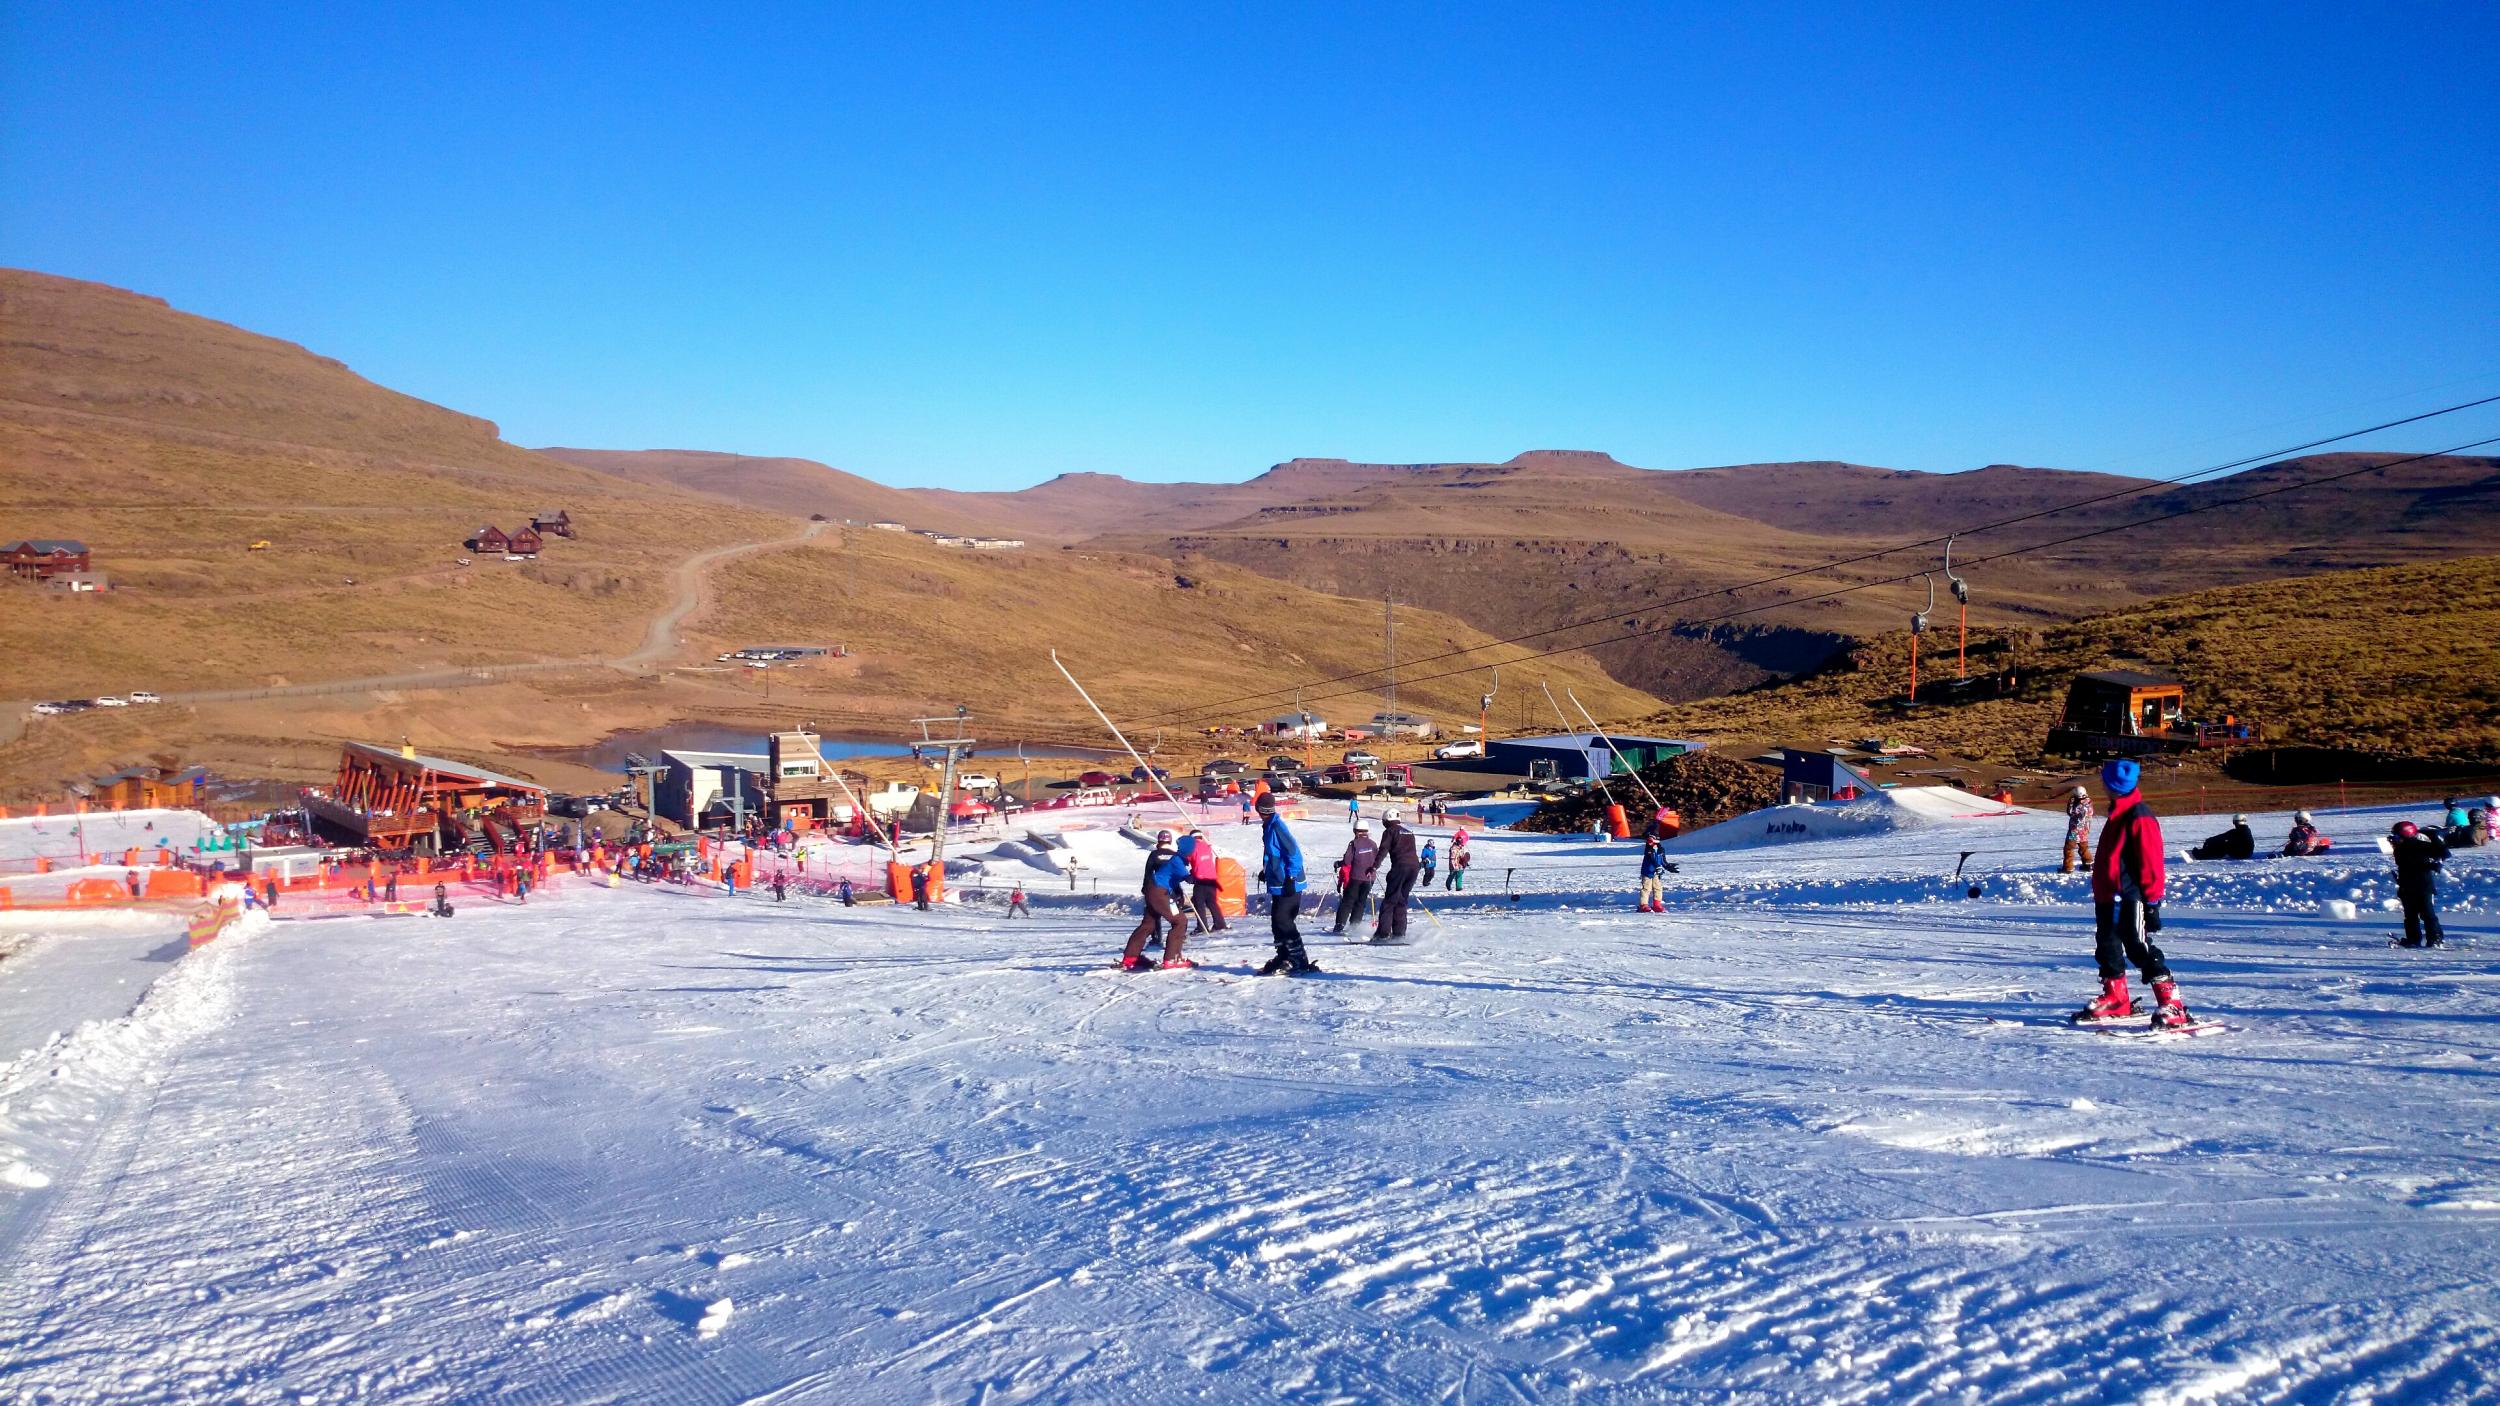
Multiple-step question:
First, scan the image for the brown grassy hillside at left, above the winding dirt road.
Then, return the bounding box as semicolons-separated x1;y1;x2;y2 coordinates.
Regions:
0;270;795;698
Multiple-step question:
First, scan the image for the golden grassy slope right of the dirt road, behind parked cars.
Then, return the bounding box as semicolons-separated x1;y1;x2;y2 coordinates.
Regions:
690;530;1655;741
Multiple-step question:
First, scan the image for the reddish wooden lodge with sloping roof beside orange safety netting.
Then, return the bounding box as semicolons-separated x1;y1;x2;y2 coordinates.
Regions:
305;743;548;856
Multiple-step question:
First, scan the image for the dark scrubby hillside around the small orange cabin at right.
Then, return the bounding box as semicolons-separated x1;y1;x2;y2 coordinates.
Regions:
1648;555;2500;763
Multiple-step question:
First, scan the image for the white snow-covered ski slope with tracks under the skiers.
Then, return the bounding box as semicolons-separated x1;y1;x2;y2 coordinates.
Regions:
0;795;2500;1403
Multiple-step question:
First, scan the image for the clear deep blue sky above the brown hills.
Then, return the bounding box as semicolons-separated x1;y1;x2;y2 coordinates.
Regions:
0;0;2500;488
